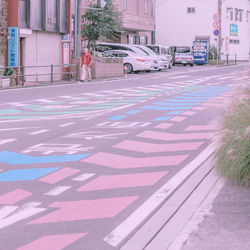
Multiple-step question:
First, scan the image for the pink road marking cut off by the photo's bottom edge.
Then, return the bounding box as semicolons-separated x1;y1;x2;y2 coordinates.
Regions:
17;233;86;250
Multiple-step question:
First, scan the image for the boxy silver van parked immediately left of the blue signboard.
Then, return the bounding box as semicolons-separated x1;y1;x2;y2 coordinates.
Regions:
170;46;194;66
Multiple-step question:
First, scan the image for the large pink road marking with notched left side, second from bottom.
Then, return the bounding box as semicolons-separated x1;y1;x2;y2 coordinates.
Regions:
28;196;138;224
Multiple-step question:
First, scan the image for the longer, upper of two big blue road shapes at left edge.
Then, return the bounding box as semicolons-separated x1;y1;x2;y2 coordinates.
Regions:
0;151;90;165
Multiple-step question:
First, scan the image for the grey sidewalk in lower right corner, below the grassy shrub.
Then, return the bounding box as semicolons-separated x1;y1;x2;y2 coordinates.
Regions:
179;183;250;250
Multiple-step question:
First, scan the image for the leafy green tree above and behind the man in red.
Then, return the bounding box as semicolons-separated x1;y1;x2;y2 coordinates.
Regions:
82;0;122;48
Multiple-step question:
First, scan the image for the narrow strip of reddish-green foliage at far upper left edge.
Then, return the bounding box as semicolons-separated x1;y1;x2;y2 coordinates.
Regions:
0;0;8;69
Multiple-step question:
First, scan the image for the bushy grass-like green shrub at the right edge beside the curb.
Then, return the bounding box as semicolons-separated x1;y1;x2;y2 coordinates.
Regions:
216;89;250;186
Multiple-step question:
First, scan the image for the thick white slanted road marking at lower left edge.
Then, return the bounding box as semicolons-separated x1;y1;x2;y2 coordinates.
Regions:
0;202;47;229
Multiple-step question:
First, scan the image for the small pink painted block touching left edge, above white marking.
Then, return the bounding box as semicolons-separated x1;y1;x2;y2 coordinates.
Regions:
0;189;32;205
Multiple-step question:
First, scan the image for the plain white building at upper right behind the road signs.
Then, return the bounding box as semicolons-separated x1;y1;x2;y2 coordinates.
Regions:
155;0;250;60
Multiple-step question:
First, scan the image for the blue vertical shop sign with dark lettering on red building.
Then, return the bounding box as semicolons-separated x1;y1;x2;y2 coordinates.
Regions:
8;27;18;67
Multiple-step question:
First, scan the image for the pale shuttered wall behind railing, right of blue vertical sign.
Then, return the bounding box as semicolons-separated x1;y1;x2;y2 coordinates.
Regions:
24;31;62;81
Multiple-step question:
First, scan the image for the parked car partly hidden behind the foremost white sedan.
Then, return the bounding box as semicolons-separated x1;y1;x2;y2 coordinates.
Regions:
95;43;158;71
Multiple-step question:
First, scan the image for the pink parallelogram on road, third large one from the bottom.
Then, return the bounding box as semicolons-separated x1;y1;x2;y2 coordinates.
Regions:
77;172;168;192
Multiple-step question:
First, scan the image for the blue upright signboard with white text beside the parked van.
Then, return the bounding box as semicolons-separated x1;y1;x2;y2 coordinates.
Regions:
193;41;208;64
